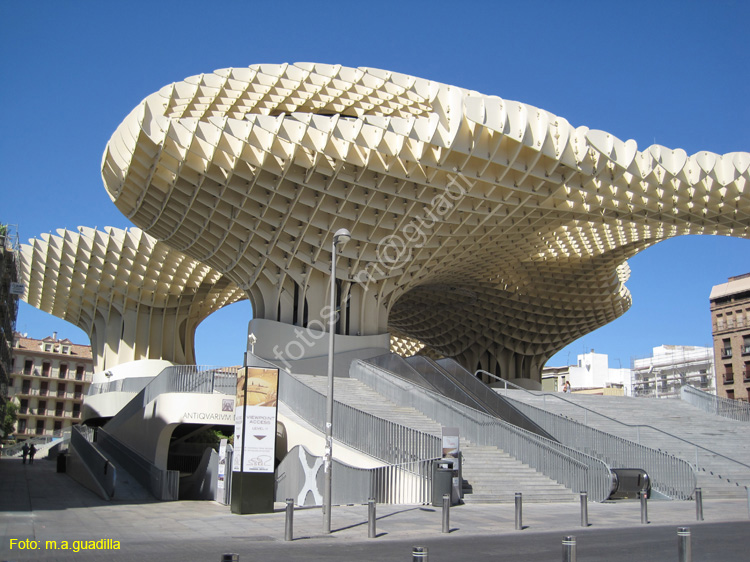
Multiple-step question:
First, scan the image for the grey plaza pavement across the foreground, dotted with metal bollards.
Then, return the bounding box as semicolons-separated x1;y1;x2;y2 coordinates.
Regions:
0;452;750;562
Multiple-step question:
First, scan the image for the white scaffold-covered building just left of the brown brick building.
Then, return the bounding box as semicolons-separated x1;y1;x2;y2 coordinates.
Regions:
633;345;716;398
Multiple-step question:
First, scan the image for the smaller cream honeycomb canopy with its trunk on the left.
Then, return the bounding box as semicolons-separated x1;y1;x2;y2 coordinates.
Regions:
21;227;246;371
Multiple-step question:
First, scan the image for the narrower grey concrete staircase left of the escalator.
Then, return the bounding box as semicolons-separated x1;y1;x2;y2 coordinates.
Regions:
294;375;577;503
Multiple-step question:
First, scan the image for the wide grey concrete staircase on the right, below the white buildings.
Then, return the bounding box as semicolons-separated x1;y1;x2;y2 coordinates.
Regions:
500;390;750;498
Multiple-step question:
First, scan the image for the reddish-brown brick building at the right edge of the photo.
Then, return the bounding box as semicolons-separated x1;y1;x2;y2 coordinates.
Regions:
710;273;750;402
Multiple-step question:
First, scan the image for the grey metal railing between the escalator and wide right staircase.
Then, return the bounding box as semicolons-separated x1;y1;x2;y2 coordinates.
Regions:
487;373;697;499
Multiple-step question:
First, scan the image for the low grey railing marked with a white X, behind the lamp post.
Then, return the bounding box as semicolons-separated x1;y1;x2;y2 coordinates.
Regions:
276;445;437;506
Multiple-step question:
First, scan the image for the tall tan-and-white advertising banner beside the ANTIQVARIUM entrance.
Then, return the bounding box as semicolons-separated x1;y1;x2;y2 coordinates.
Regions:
232;367;279;473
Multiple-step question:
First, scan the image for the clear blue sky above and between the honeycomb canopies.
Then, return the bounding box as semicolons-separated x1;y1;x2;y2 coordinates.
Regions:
0;0;750;367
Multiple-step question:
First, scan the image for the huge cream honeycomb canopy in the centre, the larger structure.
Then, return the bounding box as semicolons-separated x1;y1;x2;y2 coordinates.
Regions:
102;63;750;378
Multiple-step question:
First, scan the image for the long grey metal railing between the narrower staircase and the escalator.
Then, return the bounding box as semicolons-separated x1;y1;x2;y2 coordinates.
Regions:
350;360;612;501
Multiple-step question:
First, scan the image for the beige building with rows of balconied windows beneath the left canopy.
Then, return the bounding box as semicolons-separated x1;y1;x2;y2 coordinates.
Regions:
8;333;94;440
